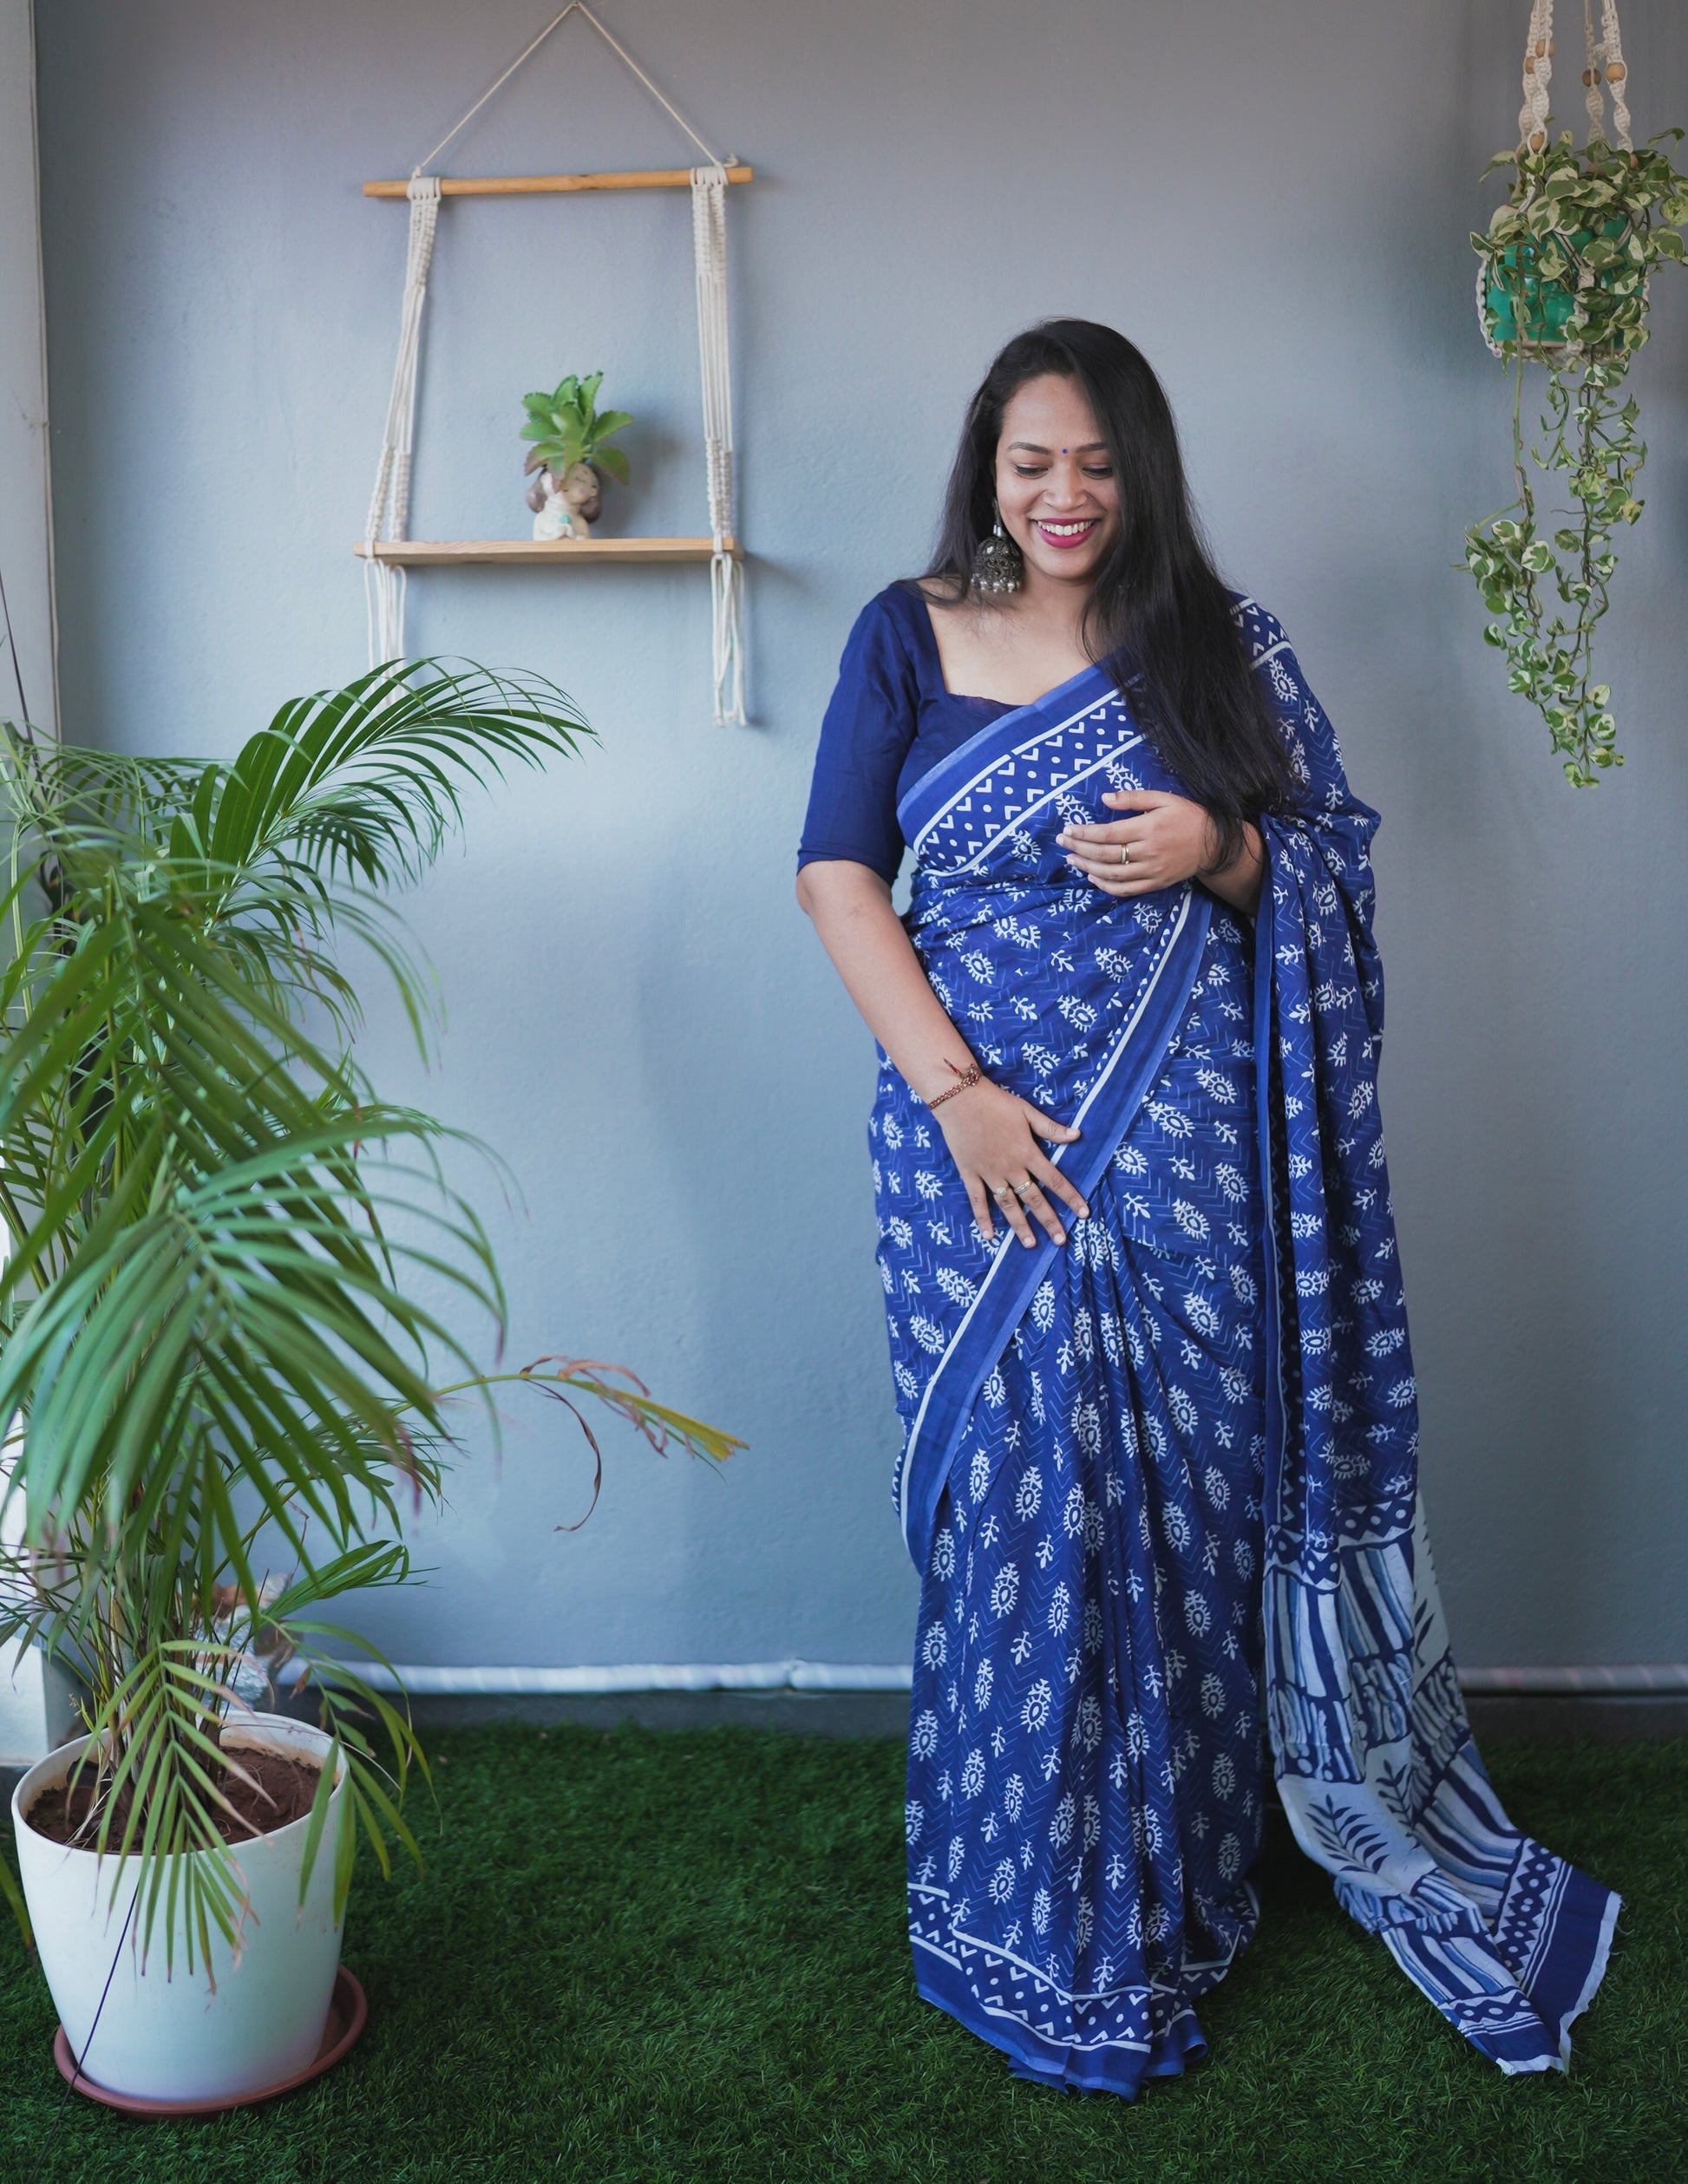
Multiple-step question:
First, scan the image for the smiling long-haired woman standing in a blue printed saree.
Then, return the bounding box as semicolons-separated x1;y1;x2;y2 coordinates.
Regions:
797;319;1618;2096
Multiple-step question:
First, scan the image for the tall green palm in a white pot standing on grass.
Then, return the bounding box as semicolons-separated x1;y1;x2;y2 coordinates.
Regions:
0;662;734;2103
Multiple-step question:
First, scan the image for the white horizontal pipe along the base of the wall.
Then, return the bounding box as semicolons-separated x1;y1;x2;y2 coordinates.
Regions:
282;1660;1688;1699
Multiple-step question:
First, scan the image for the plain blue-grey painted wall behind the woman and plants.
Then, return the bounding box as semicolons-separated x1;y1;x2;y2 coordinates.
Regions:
29;0;1688;1664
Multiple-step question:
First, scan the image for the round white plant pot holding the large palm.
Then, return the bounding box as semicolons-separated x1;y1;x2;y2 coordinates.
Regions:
11;1715;345;2101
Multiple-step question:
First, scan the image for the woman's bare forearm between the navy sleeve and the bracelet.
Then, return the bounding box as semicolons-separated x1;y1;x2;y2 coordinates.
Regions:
797;859;972;1101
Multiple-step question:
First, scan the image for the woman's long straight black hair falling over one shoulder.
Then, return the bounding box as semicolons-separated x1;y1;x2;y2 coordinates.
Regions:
926;319;1292;867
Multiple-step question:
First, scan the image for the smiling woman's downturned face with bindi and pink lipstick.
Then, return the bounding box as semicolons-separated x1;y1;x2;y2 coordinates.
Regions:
996;371;1120;585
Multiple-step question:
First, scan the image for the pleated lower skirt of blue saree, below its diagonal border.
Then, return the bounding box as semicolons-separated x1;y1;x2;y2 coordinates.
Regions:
906;919;1265;2092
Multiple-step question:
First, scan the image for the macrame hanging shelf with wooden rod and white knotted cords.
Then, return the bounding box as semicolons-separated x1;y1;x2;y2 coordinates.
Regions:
358;0;751;727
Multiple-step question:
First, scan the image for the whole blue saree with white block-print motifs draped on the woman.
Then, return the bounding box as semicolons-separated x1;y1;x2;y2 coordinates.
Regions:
869;603;1618;2096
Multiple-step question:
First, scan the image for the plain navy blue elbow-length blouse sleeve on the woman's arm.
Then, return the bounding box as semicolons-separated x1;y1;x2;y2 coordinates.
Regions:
797;598;919;882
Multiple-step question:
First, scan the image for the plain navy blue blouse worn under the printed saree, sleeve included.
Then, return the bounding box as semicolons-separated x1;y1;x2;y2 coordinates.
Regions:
797;583;1013;880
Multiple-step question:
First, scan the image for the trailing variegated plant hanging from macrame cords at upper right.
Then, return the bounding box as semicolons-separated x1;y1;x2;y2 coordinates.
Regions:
1465;123;1688;788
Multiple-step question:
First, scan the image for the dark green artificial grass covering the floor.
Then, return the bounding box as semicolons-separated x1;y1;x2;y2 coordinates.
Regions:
0;1728;1688;2184
